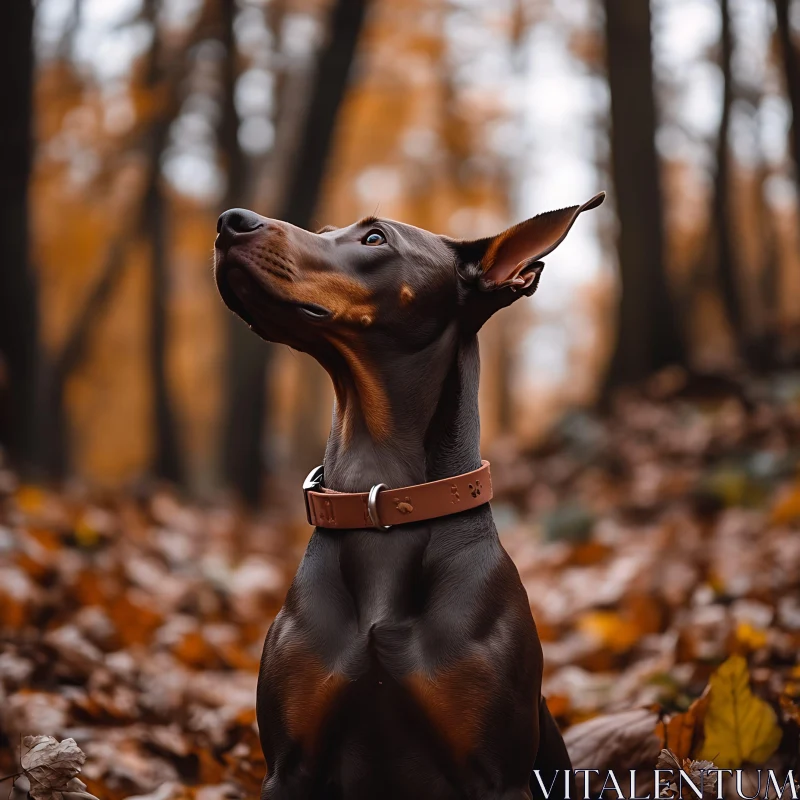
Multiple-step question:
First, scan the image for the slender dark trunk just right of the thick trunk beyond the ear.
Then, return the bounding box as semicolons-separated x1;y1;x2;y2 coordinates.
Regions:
710;0;745;353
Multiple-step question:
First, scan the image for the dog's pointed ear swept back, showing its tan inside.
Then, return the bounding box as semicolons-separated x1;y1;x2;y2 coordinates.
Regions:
451;192;606;326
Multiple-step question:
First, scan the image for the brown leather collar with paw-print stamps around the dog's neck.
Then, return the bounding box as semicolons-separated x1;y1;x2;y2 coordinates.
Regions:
303;461;492;528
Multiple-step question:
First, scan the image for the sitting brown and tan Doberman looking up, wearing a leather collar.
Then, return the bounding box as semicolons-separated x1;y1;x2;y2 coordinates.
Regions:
214;193;605;800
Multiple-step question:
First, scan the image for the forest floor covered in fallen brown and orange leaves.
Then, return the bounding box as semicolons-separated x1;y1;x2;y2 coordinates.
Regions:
0;375;800;800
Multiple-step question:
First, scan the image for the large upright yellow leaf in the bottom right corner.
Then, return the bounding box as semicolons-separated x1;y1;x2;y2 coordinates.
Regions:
699;656;781;769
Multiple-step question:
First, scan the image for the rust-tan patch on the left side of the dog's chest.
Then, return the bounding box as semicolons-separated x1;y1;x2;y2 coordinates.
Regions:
280;644;349;753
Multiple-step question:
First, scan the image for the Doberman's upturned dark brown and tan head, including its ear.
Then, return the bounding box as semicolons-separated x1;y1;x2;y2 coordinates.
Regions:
214;193;605;440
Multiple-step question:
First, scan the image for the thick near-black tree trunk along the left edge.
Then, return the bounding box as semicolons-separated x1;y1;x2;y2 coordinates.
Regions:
0;0;39;471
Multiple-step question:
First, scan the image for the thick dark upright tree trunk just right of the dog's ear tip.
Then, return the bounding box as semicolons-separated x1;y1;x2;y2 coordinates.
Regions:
605;0;686;388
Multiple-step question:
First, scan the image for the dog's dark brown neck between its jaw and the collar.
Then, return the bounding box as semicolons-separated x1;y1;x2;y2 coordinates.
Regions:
325;325;481;492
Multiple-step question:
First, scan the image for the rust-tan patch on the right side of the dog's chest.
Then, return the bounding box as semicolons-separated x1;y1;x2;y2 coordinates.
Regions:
407;656;492;761
